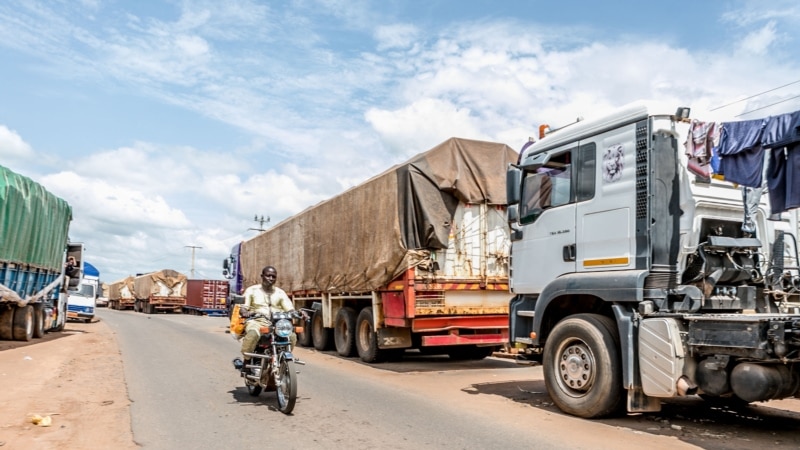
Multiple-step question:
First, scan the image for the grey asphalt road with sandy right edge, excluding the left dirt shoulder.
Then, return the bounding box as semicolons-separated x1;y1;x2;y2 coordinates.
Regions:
99;309;800;450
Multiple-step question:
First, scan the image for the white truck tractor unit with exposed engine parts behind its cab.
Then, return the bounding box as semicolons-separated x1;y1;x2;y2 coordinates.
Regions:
507;104;800;418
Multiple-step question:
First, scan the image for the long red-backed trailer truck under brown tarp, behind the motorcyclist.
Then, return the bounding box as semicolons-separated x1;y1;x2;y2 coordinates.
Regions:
223;138;517;362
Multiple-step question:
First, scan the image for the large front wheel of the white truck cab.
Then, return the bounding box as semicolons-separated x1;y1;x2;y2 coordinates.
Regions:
542;314;622;419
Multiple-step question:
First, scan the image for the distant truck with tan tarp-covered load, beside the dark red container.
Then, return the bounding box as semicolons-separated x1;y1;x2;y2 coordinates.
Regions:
133;269;191;314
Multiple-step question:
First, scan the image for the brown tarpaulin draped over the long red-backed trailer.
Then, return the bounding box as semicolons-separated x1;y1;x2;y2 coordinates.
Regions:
240;138;517;293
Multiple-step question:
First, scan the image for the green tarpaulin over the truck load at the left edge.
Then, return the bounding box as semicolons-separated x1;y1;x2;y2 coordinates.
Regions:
0;166;72;273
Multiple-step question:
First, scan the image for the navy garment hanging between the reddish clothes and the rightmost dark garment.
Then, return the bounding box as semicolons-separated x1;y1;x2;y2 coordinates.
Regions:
718;119;767;188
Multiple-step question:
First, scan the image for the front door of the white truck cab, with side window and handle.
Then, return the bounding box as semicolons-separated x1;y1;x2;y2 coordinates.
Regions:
512;149;575;294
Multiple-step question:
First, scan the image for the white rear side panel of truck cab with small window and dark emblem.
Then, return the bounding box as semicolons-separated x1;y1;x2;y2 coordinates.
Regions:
576;124;636;272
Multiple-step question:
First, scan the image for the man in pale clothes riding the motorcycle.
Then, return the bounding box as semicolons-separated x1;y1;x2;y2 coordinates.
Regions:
239;266;297;364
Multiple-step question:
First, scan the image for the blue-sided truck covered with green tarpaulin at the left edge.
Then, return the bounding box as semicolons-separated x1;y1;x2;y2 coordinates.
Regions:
0;166;74;341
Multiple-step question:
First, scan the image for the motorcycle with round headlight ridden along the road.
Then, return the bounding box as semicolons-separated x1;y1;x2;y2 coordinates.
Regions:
233;311;305;414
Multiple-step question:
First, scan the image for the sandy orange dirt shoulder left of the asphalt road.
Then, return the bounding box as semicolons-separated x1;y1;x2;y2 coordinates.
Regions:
0;321;138;449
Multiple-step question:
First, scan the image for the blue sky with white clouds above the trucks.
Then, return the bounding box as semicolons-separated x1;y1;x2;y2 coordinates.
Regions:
0;0;800;282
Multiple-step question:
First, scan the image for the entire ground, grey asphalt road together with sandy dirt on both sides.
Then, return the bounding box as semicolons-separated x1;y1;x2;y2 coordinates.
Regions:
0;309;800;449
